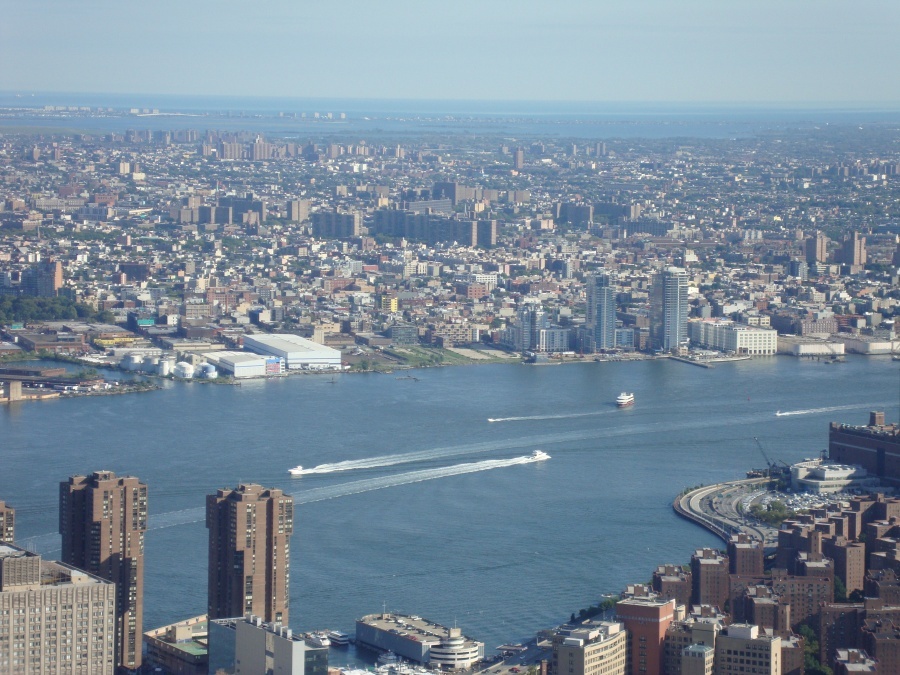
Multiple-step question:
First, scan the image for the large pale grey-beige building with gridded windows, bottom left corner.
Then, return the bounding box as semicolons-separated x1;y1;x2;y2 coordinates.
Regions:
0;544;116;675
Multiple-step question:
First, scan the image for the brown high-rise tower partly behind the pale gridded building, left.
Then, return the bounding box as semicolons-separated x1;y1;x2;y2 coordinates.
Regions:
59;471;147;670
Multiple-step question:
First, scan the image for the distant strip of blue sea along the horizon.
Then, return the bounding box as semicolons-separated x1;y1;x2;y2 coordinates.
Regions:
0;92;900;140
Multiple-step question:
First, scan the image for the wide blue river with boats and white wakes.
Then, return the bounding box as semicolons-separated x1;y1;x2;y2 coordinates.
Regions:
0;357;900;651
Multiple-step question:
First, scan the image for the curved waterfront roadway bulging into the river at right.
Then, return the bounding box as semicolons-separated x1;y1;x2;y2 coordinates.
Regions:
672;478;778;548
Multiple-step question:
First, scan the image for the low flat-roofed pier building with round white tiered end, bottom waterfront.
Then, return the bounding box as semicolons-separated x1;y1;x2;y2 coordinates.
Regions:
356;613;484;670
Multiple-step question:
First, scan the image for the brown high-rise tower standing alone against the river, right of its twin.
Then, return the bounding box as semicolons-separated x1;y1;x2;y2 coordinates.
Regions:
206;483;294;625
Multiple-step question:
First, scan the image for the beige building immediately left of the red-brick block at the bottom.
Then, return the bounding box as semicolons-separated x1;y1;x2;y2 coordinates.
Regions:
551;621;628;675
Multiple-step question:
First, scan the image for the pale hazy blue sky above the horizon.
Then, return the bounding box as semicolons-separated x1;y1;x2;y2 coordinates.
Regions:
0;0;900;104
